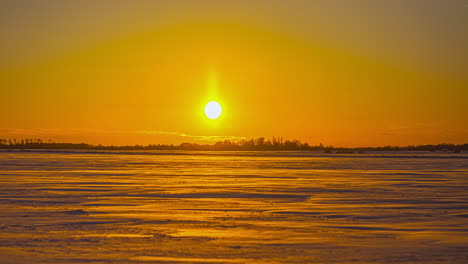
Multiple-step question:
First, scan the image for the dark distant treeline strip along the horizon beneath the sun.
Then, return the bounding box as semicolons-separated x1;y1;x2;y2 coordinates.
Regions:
0;137;468;153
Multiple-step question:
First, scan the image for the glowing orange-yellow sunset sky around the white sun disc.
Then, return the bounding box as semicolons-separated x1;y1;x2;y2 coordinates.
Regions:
0;0;468;147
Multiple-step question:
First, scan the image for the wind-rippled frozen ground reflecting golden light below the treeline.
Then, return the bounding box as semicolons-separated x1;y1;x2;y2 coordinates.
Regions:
0;151;468;264
